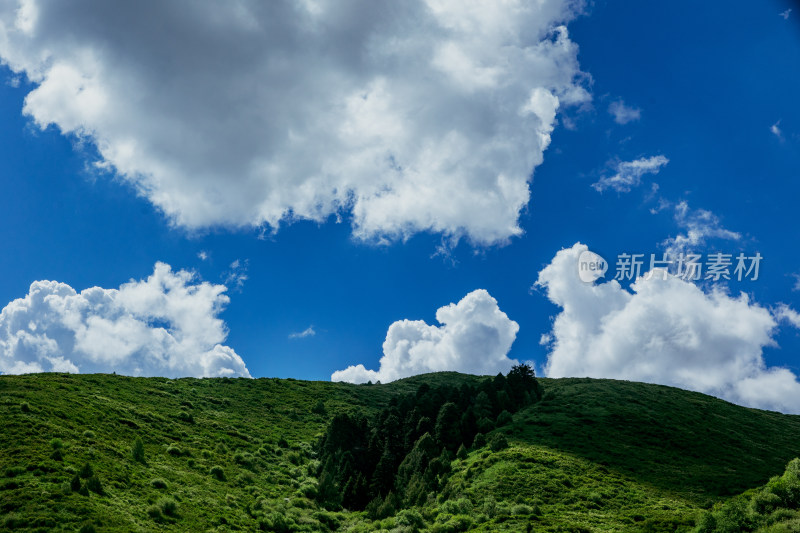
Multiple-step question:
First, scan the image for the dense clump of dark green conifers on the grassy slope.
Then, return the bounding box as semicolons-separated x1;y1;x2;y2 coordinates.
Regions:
318;365;542;516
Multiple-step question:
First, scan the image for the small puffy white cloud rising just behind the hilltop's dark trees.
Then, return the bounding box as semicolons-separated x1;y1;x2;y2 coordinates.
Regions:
331;289;519;383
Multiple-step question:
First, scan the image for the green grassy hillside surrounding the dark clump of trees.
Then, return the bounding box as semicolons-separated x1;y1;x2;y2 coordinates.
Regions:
0;373;800;532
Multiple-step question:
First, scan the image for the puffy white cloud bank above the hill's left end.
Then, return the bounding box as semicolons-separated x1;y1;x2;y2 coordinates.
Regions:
0;263;250;377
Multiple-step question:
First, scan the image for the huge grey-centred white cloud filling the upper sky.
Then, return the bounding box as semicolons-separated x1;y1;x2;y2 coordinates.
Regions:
0;0;590;243
